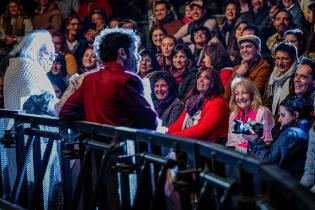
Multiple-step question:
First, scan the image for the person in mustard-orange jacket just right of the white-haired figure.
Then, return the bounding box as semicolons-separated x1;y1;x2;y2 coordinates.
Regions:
52;33;78;76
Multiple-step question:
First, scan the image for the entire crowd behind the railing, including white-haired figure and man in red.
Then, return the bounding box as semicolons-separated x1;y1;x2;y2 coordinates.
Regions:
0;0;315;192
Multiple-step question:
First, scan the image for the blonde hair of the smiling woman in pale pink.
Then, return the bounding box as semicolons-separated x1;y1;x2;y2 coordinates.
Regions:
229;78;262;114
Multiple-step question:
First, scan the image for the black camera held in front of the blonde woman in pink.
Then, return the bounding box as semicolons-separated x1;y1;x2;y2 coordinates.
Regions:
233;120;264;137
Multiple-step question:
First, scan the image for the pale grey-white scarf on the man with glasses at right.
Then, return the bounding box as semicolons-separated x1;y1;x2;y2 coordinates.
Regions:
266;61;297;116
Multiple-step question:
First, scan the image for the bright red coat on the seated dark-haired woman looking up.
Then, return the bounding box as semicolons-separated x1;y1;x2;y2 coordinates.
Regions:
168;96;229;142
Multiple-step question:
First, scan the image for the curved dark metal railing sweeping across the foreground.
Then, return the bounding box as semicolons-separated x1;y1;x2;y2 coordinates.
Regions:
0;110;315;210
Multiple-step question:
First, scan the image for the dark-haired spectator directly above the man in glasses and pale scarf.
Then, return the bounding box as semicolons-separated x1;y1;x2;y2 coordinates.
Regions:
284;29;306;60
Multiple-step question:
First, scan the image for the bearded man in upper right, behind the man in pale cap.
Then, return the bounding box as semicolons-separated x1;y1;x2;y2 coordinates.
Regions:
266;9;293;55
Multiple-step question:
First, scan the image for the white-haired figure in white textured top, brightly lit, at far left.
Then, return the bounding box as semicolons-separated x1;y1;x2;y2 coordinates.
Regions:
4;30;56;114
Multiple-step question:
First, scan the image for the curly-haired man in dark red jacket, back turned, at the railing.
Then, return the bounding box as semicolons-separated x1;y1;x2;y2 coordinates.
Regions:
59;28;157;129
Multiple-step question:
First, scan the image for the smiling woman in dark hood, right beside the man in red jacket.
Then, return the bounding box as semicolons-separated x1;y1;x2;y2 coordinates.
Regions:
150;71;184;127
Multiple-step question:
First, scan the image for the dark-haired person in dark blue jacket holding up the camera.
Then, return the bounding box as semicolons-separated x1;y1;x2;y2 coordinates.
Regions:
249;98;309;179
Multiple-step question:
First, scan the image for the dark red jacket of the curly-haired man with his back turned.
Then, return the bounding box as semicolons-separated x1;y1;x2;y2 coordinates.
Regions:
59;62;157;129
